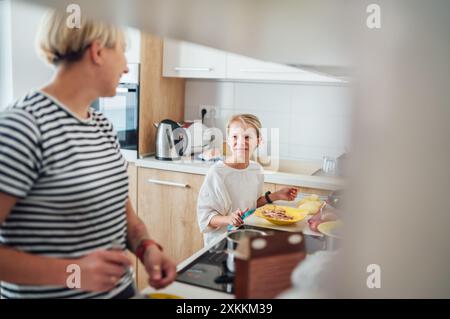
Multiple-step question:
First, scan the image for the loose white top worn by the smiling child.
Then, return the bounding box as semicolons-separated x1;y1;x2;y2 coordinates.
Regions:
197;162;264;245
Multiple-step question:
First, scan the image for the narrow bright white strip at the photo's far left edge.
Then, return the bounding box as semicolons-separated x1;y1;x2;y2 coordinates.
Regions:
0;0;13;110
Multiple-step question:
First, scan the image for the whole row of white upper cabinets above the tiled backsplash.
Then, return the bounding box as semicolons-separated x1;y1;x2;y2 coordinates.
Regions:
163;39;345;83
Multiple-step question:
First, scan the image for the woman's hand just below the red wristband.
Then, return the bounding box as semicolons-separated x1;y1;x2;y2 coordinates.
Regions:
144;245;177;289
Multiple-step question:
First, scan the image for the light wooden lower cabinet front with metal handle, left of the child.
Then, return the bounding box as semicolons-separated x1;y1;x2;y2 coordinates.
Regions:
134;168;204;289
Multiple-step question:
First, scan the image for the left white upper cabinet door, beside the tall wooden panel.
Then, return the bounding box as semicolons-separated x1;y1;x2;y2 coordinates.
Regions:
163;39;227;79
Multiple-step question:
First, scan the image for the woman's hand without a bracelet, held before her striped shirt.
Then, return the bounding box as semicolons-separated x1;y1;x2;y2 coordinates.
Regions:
74;250;131;292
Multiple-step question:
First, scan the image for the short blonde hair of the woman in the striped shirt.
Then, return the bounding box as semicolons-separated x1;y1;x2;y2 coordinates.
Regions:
37;10;125;65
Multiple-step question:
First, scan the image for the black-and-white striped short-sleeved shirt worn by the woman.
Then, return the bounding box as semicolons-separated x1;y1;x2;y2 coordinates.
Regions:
0;91;132;298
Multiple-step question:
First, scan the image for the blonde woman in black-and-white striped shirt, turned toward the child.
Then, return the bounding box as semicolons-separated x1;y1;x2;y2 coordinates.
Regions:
0;12;176;298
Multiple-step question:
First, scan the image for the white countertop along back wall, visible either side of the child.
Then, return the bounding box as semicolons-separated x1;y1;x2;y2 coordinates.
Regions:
134;157;345;191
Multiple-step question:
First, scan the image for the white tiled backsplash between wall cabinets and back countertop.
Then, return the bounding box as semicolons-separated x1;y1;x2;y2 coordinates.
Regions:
185;80;351;161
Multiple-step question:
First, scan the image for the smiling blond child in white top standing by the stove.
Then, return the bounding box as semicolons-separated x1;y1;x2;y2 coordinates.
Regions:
197;114;297;245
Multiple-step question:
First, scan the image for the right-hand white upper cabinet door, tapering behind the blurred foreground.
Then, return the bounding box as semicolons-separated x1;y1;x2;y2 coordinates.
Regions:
227;53;342;83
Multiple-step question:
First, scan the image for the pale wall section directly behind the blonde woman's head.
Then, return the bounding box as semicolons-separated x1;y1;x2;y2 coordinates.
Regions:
11;1;53;99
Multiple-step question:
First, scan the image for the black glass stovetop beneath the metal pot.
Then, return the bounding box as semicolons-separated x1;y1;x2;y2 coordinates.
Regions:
176;225;324;294
